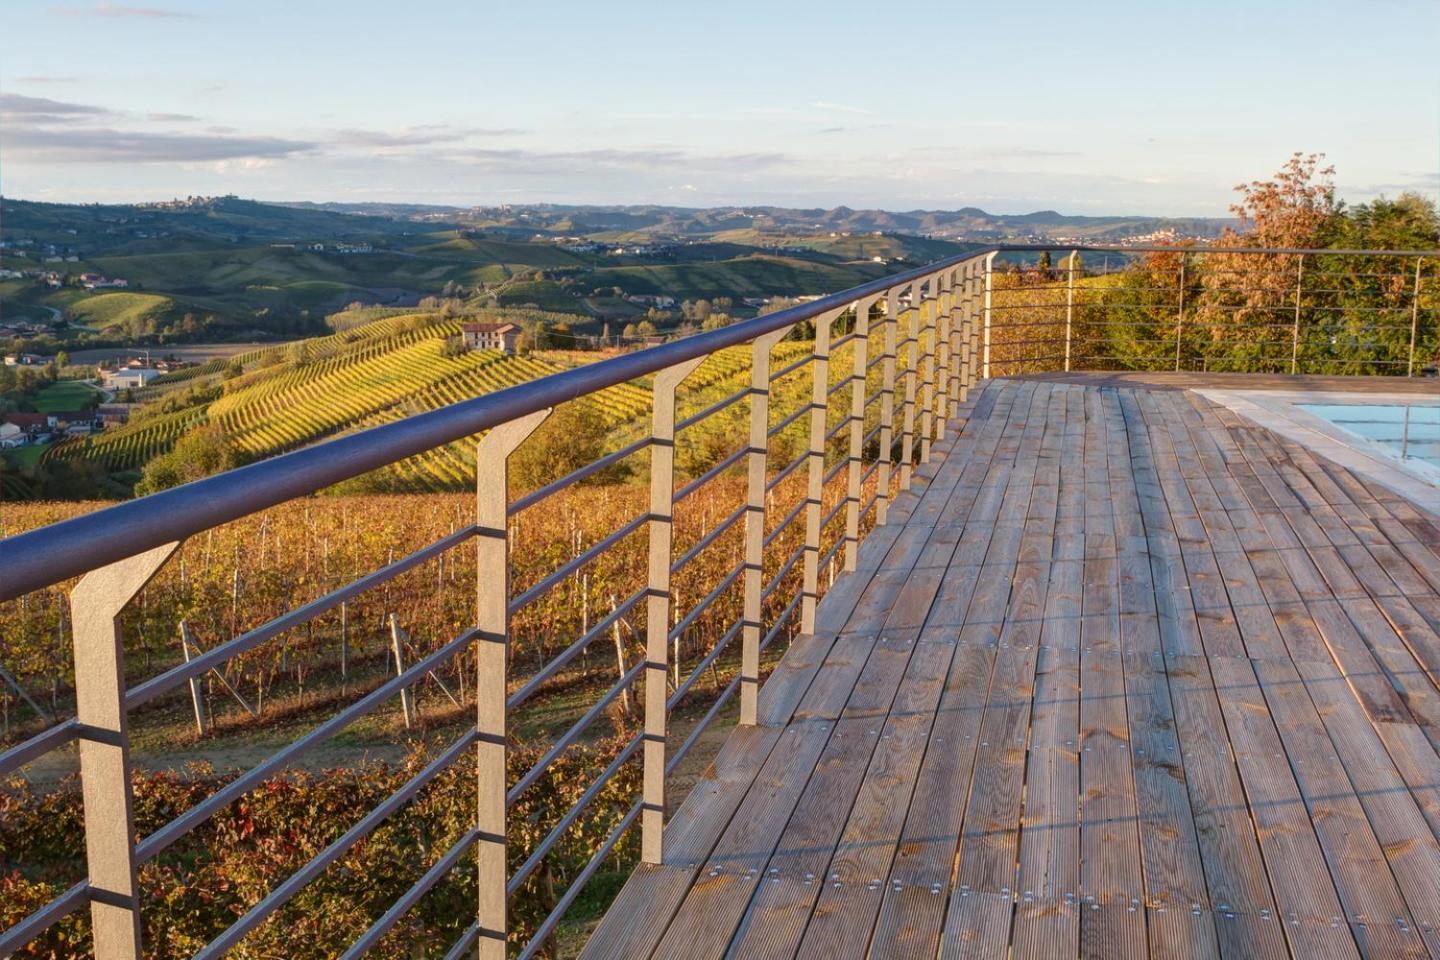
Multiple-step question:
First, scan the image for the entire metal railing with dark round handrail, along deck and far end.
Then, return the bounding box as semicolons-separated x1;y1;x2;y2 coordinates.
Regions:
0;245;1440;960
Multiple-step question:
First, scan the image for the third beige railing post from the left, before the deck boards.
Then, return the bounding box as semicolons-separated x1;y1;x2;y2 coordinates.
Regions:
639;357;704;864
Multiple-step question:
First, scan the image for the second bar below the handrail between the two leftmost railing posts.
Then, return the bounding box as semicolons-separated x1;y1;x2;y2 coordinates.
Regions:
135;629;480;865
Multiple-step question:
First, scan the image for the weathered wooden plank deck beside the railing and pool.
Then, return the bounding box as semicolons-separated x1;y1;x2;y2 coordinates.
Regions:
583;377;1440;960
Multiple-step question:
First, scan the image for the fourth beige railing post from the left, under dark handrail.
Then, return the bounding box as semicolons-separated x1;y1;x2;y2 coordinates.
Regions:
740;325;793;724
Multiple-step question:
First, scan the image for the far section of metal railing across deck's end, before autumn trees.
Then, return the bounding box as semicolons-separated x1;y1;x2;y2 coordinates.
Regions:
973;246;1440;376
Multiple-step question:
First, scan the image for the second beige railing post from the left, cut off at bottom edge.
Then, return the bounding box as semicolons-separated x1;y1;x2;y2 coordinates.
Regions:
475;410;550;960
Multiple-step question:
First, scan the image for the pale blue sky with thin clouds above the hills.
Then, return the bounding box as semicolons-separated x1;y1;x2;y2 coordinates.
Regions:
0;0;1440;216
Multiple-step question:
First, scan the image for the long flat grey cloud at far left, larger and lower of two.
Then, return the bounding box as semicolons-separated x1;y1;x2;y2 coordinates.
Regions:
6;127;318;163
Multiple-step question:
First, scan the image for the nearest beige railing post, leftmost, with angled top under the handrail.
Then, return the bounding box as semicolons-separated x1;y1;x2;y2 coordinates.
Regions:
71;543;180;960
